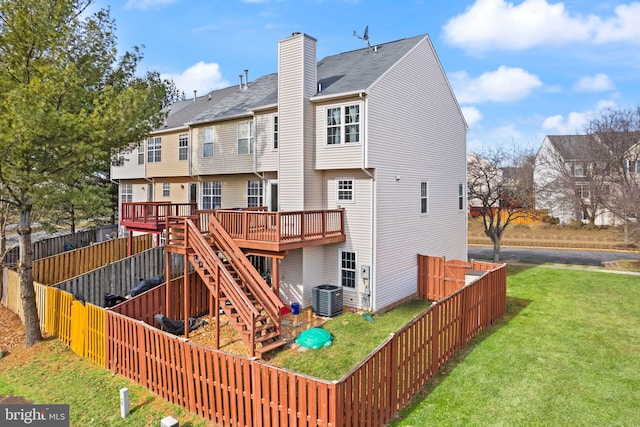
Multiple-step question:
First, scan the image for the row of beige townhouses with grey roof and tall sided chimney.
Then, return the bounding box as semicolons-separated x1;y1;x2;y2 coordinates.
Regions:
112;33;467;311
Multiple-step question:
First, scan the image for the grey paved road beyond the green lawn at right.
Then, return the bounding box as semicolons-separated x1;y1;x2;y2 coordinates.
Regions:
469;246;638;266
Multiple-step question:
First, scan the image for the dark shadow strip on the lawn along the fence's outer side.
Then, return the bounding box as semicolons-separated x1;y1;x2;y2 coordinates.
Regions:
388;298;531;426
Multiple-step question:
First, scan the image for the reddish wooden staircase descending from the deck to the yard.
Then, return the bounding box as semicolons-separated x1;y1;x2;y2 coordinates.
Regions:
174;216;286;357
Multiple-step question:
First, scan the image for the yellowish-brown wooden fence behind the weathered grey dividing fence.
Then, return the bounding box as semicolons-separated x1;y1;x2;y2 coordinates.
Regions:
33;234;153;285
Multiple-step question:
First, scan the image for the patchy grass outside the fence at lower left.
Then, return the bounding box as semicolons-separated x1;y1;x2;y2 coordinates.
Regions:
0;339;209;427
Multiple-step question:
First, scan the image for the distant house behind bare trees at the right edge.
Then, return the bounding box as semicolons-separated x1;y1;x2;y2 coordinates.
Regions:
534;133;640;226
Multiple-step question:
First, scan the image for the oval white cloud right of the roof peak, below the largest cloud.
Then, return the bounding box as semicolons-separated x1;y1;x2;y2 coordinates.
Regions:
449;65;542;104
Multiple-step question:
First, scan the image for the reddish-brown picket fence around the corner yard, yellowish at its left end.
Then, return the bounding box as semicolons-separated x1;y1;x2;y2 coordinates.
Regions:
2;254;506;427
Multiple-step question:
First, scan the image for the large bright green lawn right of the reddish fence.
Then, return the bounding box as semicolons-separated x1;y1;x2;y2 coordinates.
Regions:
392;267;640;426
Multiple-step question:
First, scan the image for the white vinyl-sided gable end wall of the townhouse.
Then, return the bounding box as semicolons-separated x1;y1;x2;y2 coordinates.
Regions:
364;36;467;311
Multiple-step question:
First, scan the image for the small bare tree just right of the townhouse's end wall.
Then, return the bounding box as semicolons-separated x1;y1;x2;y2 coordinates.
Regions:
467;147;534;262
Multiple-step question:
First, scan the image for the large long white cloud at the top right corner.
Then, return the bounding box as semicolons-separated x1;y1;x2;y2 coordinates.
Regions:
443;0;640;51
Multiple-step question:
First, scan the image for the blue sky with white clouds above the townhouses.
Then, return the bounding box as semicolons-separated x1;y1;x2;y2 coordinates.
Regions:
96;0;640;151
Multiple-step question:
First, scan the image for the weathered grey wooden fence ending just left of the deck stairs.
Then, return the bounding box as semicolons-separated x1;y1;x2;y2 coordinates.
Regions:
53;247;184;307
